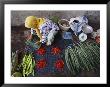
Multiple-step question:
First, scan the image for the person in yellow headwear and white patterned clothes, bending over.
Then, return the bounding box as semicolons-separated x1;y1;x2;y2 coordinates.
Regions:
25;16;59;45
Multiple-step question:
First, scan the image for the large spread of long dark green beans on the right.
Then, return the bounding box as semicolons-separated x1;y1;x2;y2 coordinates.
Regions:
65;41;100;75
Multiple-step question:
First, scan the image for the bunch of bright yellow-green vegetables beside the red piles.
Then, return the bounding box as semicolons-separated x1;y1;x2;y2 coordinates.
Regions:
22;53;35;77
